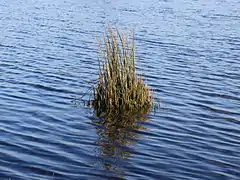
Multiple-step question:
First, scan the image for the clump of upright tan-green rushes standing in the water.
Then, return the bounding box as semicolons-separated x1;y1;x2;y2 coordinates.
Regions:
93;28;153;117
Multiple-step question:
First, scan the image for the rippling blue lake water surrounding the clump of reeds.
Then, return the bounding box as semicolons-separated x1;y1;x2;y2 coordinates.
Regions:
0;0;240;180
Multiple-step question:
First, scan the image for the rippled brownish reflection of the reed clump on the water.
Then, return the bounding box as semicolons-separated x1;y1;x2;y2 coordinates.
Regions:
95;116;149;178
